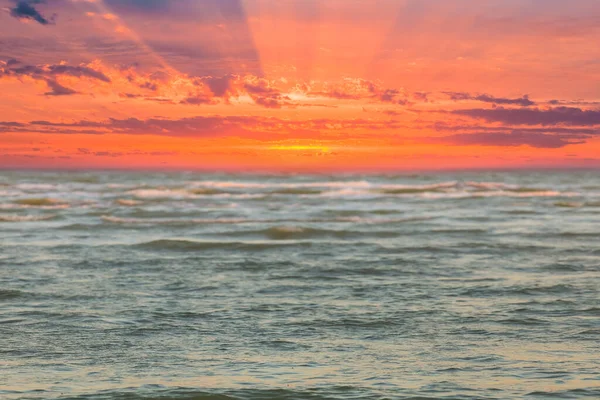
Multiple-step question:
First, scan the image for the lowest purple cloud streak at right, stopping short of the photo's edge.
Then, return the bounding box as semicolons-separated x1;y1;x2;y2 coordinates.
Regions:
442;131;585;149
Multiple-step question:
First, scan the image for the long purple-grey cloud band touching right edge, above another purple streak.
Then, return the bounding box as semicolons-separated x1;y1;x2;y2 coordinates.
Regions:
451;107;600;126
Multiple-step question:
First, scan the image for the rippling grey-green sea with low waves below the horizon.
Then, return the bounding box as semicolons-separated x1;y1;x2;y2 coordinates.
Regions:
0;172;600;400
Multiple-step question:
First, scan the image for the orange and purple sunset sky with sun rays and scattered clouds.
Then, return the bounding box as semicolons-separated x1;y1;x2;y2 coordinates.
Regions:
0;0;600;172
